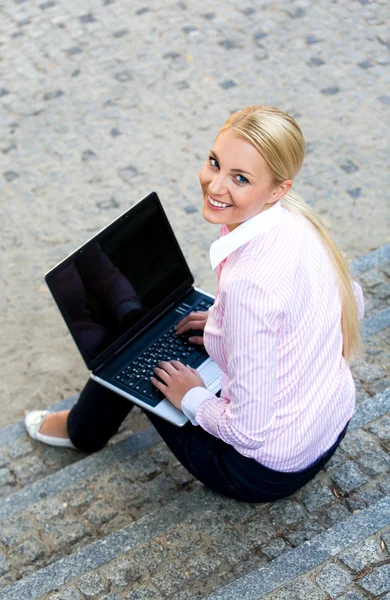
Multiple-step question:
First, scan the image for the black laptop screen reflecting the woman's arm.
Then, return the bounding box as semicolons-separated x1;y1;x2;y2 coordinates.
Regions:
46;193;193;368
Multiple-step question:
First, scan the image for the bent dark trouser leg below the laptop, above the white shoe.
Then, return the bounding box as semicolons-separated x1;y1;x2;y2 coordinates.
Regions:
67;379;134;452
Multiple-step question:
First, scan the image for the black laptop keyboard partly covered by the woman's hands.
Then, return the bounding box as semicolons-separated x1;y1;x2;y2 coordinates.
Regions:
115;300;213;406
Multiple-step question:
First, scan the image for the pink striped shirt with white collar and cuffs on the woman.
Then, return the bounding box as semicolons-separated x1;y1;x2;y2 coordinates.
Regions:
182;201;364;472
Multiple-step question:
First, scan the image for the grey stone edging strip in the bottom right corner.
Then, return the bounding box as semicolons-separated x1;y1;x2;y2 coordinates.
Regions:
204;496;390;600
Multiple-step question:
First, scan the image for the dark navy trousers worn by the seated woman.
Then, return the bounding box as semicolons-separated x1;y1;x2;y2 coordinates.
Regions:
68;379;348;502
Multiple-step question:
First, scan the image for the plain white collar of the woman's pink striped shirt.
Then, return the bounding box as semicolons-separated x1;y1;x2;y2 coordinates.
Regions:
210;200;282;270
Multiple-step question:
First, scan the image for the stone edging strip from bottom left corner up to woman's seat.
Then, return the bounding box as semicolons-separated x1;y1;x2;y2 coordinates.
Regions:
0;489;214;600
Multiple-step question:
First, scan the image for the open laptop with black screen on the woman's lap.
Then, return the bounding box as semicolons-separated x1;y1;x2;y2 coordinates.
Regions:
45;192;221;426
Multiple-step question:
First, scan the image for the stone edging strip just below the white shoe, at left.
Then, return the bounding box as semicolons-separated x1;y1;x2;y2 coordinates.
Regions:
0;427;161;519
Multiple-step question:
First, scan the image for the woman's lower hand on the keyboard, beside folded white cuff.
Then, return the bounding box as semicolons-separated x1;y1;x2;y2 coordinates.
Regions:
150;360;206;410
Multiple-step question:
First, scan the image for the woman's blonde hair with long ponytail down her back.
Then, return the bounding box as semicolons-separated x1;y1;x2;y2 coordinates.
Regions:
218;105;360;363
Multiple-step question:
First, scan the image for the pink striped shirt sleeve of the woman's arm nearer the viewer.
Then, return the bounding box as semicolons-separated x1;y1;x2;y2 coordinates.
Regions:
190;279;282;451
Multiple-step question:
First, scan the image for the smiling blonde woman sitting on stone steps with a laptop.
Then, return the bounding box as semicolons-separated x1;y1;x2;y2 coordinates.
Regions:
26;106;364;502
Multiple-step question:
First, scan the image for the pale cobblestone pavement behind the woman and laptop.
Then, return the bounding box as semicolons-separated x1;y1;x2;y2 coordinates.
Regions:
0;0;390;425
